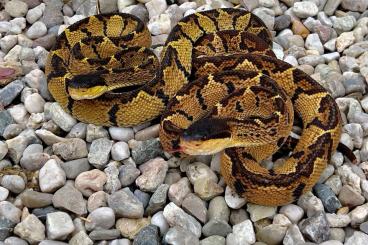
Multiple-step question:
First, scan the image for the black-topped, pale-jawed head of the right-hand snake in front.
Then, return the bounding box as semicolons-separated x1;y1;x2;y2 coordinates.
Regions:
180;118;235;155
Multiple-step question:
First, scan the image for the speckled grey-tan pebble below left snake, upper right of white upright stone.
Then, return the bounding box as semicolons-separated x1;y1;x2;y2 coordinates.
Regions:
52;138;88;161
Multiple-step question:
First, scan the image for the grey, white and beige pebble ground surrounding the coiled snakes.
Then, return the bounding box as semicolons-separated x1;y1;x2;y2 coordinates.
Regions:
0;0;368;245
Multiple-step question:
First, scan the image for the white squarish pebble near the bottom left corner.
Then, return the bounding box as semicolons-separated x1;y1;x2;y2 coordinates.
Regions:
46;212;74;240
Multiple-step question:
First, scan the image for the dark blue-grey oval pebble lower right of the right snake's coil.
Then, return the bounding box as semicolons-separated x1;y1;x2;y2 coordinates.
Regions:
314;183;342;213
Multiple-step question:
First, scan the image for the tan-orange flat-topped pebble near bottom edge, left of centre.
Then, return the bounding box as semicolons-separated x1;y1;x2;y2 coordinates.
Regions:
115;218;150;239
